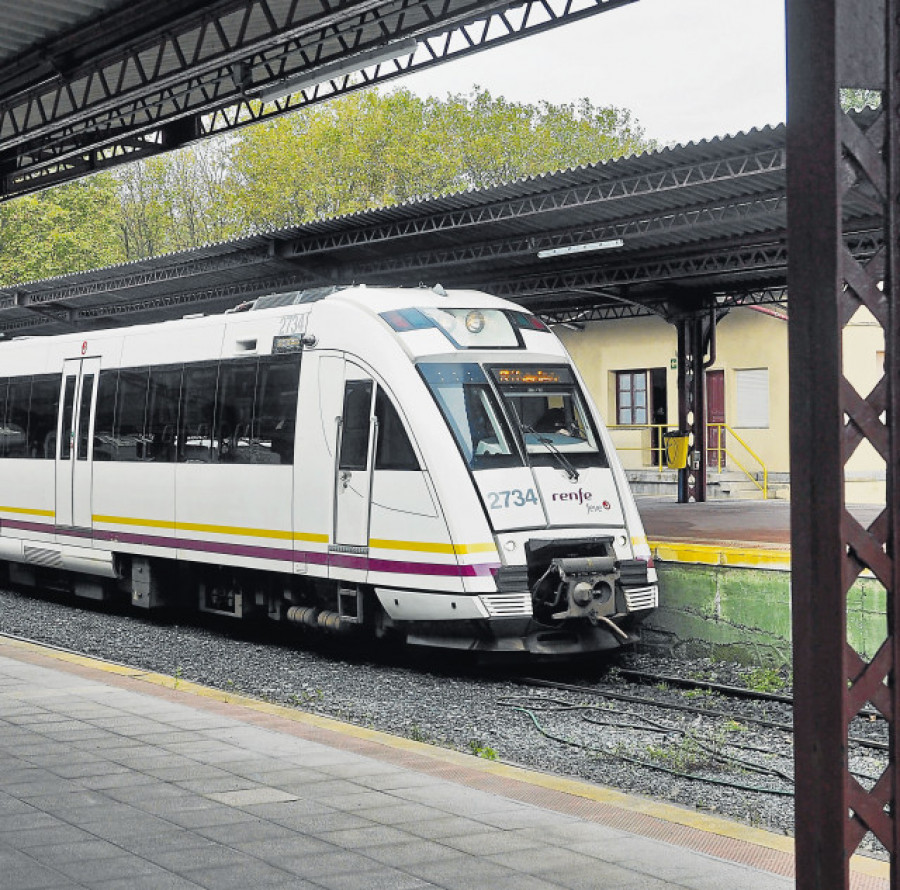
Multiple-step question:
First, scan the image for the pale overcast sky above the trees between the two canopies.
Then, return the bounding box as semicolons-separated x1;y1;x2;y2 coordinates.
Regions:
394;0;786;145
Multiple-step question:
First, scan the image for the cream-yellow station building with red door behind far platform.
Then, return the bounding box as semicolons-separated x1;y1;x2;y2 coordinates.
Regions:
555;306;885;504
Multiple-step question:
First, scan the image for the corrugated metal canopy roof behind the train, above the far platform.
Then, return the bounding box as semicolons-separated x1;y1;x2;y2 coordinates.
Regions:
0;126;824;334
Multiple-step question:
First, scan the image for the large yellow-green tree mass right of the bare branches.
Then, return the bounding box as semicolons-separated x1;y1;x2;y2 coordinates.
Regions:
221;87;655;230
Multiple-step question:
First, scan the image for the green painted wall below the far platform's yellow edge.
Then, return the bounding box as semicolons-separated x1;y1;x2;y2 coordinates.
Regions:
642;562;887;667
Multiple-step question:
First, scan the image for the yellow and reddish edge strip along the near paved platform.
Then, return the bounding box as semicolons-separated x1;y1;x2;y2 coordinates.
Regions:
0;638;890;880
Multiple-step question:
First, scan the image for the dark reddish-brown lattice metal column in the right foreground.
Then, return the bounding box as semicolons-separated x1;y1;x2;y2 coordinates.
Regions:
787;0;900;890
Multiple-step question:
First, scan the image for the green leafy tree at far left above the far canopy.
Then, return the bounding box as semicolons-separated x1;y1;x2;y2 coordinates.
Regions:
0;174;125;285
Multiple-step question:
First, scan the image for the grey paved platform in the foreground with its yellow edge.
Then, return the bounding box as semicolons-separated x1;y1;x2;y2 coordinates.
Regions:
0;638;888;890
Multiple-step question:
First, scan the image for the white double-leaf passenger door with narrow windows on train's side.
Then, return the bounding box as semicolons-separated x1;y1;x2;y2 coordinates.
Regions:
56;358;100;529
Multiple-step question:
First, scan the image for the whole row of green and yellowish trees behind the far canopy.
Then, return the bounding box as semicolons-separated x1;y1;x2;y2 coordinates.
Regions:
0;87;655;283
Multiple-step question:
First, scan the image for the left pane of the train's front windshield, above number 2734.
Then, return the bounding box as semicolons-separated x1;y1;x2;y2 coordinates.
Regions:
419;363;524;470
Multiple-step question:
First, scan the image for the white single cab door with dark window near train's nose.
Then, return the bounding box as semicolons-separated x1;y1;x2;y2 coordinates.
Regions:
334;362;375;552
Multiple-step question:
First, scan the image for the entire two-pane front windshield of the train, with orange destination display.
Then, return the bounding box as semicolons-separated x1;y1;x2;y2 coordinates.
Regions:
419;363;608;470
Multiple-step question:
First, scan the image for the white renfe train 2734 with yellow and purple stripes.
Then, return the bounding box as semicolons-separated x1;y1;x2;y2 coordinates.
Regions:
0;287;657;655
